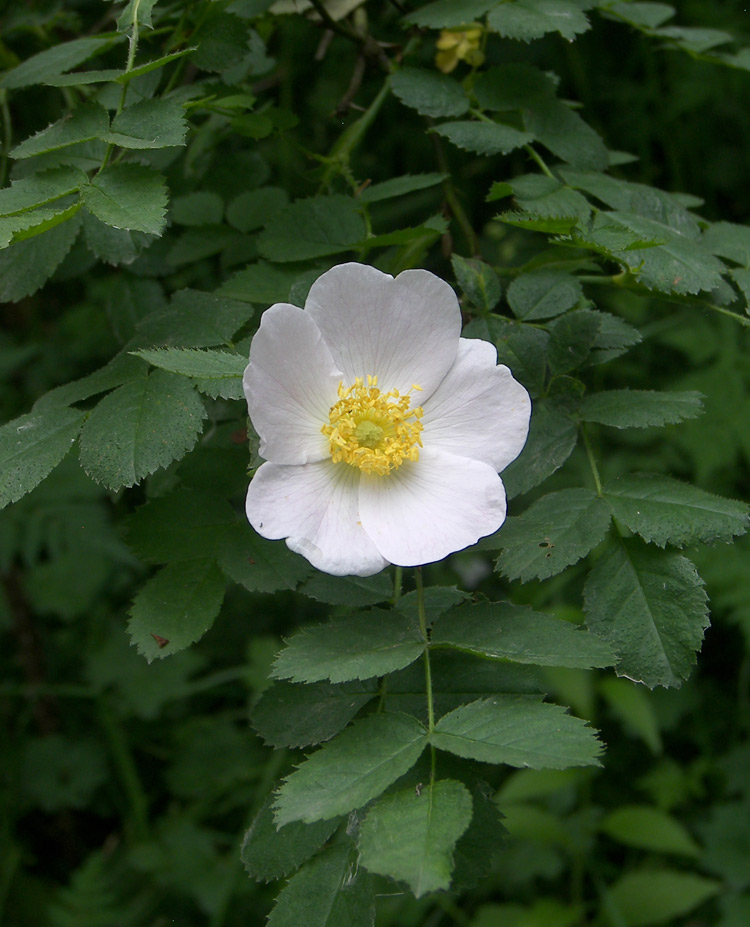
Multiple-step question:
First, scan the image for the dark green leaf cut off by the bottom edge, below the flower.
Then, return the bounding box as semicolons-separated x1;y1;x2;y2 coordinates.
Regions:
268;844;375;927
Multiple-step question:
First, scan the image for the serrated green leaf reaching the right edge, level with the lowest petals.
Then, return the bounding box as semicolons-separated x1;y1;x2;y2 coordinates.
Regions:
604;473;748;547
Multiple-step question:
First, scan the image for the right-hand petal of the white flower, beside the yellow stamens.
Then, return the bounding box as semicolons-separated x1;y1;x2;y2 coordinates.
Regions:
422;338;531;471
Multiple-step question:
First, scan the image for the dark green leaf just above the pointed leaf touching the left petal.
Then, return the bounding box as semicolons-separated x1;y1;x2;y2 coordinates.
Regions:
135;289;255;348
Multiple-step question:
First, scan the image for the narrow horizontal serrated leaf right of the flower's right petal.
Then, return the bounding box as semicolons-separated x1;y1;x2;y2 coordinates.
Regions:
578;389;703;428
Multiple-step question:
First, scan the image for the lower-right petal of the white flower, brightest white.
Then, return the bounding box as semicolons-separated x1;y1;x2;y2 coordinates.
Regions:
359;449;505;566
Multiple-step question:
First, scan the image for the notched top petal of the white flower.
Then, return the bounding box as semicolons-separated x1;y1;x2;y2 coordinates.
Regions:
305;263;461;404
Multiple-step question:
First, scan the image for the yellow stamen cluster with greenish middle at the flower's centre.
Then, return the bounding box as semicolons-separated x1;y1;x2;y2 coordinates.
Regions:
321;376;422;476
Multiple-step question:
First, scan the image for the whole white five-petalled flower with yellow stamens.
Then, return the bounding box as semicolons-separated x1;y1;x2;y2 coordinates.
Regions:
243;263;531;576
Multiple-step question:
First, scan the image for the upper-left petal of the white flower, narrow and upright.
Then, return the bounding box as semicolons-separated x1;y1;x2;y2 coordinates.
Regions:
243;303;341;464
